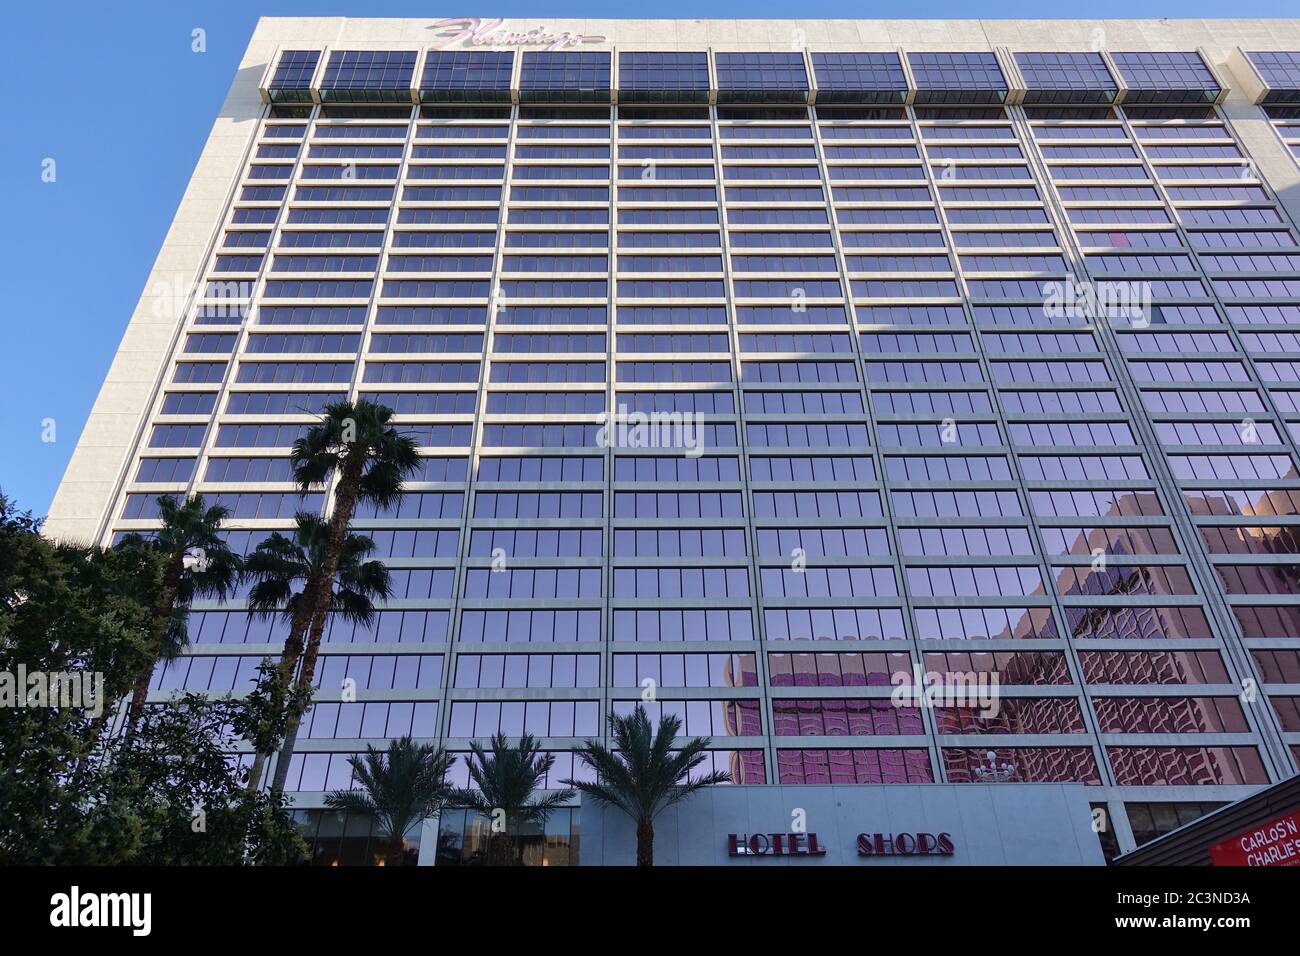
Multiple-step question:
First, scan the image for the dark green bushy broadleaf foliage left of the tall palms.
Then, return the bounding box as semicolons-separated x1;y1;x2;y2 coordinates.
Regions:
0;494;306;865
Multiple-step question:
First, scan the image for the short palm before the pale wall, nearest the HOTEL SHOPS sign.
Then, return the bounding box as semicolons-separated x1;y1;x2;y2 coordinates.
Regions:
564;704;731;866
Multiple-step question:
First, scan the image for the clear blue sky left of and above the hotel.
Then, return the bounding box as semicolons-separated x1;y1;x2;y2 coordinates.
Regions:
0;0;1300;514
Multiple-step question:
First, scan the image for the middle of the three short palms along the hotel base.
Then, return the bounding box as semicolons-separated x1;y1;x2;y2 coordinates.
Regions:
451;734;573;866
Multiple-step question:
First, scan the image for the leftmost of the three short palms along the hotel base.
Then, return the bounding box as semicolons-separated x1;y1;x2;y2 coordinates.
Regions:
325;736;455;866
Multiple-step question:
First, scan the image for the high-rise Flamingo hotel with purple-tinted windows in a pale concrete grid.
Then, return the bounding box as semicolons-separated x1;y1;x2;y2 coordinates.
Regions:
47;17;1300;864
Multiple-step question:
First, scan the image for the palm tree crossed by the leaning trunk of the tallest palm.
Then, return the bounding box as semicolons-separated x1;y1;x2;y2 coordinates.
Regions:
244;511;393;791
